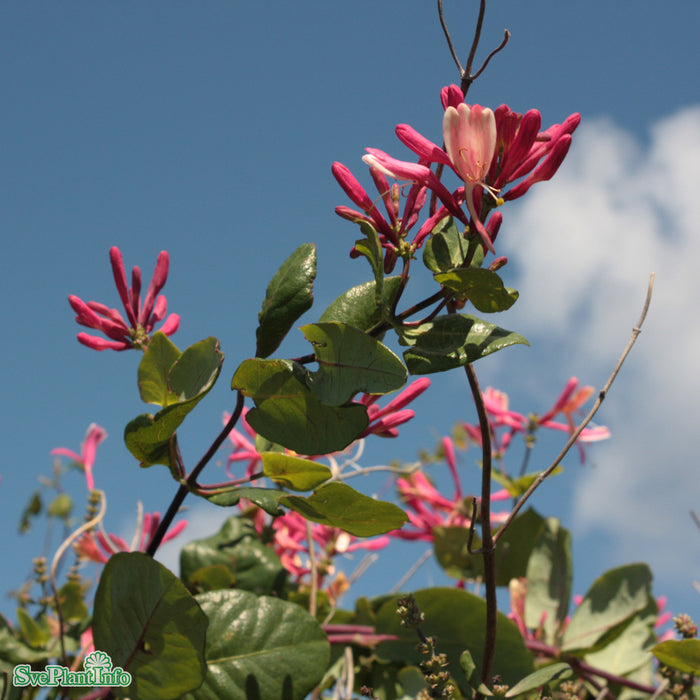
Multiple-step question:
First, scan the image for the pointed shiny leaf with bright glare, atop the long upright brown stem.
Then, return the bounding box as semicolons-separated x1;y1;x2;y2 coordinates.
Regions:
402;314;529;374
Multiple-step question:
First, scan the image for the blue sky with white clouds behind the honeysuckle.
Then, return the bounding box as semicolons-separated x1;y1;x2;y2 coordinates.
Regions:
0;0;700;614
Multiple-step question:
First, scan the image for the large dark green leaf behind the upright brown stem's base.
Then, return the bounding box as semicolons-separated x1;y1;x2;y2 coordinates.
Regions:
376;588;534;693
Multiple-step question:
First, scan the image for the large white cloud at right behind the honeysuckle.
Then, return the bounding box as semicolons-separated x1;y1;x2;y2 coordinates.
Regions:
501;107;700;600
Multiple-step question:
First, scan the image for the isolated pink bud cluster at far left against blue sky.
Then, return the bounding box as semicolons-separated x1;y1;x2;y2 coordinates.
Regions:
68;246;180;350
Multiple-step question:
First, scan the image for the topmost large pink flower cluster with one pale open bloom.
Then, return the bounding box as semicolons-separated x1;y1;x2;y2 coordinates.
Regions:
333;85;581;258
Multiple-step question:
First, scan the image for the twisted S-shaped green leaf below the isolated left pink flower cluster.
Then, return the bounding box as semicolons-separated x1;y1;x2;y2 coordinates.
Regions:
124;338;224;469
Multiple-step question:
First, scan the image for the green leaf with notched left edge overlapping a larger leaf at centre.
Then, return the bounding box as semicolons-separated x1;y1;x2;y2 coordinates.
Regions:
301;323;406;406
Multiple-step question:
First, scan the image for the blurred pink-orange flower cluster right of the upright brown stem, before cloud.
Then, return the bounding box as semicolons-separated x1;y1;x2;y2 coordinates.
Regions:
464;377;610;461
